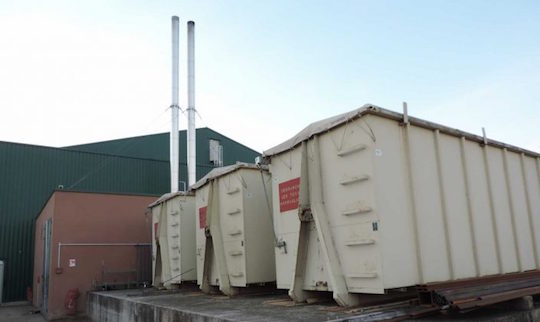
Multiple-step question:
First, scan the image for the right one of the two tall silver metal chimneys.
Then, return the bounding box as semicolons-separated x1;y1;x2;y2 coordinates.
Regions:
187;21;197;186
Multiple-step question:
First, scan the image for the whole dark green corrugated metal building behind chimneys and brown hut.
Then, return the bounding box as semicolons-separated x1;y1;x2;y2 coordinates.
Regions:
0;128;259;302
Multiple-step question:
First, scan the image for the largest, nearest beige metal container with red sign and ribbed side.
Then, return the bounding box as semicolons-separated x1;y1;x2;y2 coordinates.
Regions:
264;105;540;305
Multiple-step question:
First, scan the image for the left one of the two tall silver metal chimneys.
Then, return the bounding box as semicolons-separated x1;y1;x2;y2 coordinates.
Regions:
170;16;180;192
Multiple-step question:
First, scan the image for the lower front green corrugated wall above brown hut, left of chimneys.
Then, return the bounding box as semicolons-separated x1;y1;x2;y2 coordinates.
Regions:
0;142;169;302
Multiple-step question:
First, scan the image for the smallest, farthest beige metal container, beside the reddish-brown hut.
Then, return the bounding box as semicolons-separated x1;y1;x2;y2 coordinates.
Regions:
149;192;197;289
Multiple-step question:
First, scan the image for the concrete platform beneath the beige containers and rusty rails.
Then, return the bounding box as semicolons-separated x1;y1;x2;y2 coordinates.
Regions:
87;287;540;322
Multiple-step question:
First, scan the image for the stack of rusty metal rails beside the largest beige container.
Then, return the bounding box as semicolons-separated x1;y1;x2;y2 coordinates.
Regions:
417;270;540;312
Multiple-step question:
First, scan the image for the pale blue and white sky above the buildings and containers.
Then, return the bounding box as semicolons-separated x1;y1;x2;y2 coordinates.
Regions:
0;0;540;152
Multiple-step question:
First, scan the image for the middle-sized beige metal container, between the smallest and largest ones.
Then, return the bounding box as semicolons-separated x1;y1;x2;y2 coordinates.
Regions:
192;163;276;295
